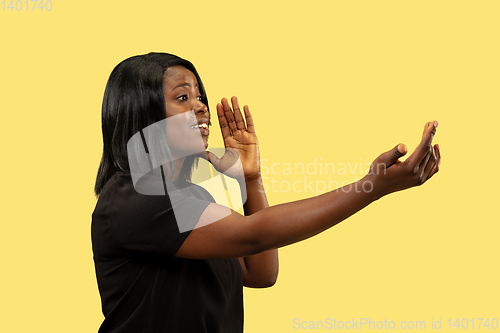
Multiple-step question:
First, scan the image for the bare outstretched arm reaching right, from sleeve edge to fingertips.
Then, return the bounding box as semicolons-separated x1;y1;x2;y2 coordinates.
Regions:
188;102;441;259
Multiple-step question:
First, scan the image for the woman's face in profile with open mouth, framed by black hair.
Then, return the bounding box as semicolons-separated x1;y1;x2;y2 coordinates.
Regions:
163;66;210;156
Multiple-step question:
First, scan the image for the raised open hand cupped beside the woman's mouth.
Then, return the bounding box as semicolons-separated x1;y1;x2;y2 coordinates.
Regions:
202;96;260;180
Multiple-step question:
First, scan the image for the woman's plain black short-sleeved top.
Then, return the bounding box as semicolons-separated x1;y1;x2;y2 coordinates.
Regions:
91;172;243;333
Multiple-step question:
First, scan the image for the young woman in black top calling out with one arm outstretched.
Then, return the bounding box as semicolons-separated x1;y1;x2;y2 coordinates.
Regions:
92;53;441;333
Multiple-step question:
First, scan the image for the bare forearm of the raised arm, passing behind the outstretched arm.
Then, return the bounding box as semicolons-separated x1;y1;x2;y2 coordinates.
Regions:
240;177;279;288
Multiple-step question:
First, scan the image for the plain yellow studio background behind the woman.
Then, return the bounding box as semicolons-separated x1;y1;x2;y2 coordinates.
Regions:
0;0;500;333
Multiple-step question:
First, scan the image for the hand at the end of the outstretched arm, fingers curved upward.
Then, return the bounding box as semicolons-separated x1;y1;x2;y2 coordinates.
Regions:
365;121;441;198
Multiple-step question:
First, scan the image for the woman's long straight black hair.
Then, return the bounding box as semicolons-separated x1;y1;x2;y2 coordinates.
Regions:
94;52;208;196
